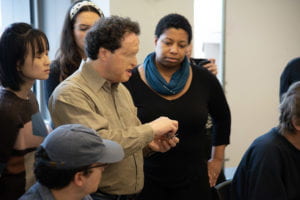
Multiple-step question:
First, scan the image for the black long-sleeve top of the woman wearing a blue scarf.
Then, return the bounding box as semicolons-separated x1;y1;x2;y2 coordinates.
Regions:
125;66;231;186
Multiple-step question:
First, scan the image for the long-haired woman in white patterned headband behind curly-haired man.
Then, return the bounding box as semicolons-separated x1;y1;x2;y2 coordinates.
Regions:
44;0;104;102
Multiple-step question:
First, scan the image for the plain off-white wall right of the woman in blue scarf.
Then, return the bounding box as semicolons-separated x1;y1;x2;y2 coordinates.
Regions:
225;0;300;167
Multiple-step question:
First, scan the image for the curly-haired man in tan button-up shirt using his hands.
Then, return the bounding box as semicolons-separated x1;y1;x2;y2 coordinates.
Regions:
49;16;178;200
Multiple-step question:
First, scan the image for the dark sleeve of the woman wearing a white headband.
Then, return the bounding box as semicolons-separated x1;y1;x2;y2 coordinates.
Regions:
44;60;60;103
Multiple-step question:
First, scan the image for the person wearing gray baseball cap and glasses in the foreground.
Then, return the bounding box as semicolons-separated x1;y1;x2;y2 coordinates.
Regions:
20;124;124;200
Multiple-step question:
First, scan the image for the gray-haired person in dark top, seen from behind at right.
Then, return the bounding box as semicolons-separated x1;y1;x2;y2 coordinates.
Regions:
231;81;300;200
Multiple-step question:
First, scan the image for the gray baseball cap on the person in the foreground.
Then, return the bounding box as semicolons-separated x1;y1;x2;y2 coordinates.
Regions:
41;124;124;169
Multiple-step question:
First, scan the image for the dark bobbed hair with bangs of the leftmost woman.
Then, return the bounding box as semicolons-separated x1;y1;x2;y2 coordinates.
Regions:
0;23;49;91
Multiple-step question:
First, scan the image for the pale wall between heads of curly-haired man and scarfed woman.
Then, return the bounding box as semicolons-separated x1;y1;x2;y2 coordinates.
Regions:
110;0;194;63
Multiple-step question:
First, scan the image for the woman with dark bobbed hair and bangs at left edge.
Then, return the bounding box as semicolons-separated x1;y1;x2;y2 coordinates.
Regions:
0;23;50;200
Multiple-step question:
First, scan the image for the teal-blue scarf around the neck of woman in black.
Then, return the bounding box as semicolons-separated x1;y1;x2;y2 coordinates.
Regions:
144;52;190;95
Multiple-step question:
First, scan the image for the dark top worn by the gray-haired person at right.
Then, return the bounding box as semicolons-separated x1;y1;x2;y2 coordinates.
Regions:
231;128;300;200
